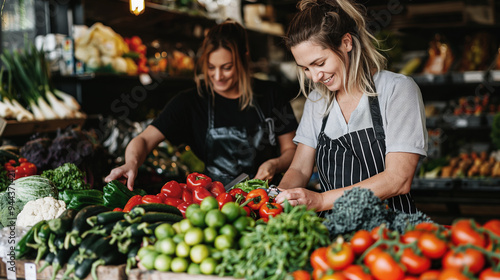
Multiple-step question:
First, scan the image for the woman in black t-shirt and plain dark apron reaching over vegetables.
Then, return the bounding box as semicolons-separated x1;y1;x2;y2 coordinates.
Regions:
105;21;297;189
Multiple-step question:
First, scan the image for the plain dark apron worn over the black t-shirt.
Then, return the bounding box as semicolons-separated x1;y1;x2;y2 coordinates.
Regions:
205;95;277;185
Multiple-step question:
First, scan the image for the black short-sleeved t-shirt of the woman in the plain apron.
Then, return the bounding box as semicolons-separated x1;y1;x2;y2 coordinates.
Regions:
151;79;298;162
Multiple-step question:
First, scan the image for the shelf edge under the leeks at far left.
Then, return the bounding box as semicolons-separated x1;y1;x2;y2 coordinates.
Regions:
0;118;86;136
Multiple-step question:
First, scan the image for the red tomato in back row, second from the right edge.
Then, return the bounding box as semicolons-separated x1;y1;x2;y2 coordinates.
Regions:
451;219;486;248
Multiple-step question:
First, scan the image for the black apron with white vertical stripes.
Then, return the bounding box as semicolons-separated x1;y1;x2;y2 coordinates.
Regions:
316;96;416;216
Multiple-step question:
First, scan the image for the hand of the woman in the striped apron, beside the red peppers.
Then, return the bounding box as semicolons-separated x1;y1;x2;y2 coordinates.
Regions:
274;188;324;211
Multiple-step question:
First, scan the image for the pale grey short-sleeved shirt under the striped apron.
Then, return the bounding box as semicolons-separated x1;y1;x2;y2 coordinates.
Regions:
293;71;427;156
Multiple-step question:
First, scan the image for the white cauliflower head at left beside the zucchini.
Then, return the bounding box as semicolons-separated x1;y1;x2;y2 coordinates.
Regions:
16;196;66;227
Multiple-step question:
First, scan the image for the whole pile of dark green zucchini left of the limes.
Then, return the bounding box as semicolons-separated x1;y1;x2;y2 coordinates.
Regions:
16;204;183;279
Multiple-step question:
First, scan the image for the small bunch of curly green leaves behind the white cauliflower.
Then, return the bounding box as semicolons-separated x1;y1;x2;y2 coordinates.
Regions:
42;162;90;191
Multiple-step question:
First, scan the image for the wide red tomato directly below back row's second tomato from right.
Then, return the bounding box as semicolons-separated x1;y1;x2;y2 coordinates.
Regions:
442;248;485;274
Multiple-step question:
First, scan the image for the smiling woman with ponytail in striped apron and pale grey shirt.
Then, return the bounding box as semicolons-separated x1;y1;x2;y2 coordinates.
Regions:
276;0;427;214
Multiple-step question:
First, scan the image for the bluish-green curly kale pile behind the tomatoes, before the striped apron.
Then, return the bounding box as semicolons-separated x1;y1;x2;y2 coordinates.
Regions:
323;187;432;240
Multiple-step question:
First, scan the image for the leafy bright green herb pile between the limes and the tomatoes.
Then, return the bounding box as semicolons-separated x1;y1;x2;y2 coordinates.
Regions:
217;201;330;280
